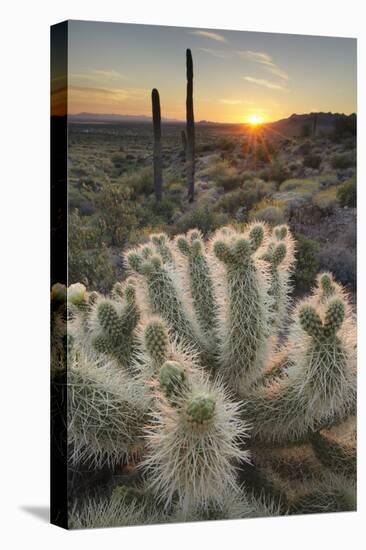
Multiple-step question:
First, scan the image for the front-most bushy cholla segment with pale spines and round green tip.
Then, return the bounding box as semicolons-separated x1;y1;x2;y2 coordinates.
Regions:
142;376;248;513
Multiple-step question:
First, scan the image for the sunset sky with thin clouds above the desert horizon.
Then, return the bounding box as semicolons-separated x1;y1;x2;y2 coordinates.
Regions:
68;21;356;122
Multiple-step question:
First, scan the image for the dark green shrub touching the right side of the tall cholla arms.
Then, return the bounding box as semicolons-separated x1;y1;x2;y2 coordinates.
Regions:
294;235;320;292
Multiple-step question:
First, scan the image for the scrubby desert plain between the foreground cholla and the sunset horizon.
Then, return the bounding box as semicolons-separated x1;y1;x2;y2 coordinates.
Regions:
69;113;356;302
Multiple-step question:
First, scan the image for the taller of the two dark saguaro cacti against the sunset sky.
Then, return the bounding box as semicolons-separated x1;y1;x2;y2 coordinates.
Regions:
186;49;195;202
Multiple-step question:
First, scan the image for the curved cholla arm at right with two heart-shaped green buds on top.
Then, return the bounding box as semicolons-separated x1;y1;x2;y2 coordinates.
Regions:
246;298;356;443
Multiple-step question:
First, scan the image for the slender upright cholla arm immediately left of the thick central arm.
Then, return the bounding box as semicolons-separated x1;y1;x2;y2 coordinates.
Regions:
176;231;217;335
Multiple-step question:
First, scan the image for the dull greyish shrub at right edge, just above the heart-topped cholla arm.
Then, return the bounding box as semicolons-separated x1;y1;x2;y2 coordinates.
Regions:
318;243;357;290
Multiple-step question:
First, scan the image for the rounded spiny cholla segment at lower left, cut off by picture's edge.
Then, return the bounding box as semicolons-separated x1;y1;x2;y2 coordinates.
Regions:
67;351;150;467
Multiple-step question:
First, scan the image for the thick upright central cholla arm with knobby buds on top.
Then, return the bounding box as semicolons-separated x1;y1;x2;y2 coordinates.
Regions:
213;236;270;391
